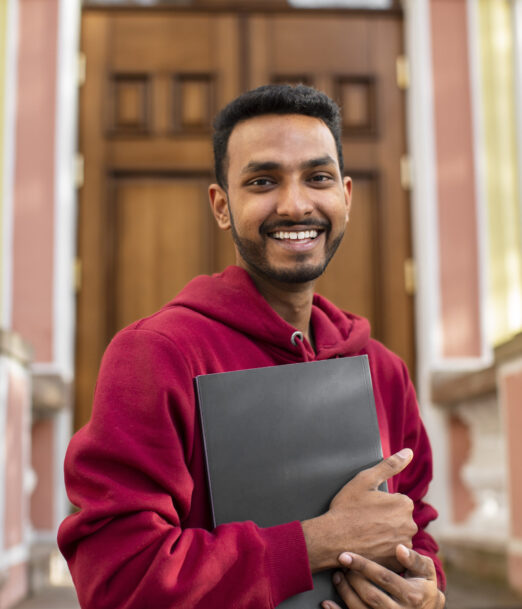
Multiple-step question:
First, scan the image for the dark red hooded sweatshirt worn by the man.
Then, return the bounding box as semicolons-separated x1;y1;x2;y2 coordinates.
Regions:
58;267;444;609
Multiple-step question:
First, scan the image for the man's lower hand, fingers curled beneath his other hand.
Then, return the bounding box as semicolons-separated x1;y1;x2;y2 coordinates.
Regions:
322;545;445;609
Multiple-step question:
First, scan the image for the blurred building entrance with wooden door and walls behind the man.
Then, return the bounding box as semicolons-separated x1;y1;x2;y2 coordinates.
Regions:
0;0;522;609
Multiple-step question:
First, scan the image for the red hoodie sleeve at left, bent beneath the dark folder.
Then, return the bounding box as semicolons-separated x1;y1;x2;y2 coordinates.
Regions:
58;330;312;609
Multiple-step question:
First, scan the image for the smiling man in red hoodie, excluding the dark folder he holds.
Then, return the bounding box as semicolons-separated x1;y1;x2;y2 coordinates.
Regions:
59;85;444;609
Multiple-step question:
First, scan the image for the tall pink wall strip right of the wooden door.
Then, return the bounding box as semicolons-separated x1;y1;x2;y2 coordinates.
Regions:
429;0;482;358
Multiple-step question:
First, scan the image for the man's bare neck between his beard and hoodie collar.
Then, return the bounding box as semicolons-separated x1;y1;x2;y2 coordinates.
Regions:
243;267;315;344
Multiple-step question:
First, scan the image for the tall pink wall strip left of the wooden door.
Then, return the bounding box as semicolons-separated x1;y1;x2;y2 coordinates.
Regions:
12;0;58;363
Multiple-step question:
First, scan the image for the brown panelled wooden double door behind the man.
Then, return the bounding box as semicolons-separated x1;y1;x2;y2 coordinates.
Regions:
75;9;413;427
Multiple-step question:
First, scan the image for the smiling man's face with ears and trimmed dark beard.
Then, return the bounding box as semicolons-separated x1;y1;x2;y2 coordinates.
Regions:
210;114;351;283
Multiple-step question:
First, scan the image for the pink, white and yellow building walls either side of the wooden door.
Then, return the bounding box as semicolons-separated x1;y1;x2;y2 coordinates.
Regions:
0;0;522;609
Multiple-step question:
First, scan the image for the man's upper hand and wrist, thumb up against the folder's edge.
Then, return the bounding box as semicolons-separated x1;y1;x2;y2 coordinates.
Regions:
302;448;417;573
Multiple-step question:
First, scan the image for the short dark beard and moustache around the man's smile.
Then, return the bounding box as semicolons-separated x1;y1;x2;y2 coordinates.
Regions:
229;206;344;283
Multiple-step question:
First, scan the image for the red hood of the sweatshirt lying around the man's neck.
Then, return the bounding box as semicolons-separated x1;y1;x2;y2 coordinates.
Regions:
167;266;370;361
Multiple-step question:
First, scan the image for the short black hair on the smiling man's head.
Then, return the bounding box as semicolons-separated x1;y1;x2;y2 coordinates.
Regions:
213;84;344;190
